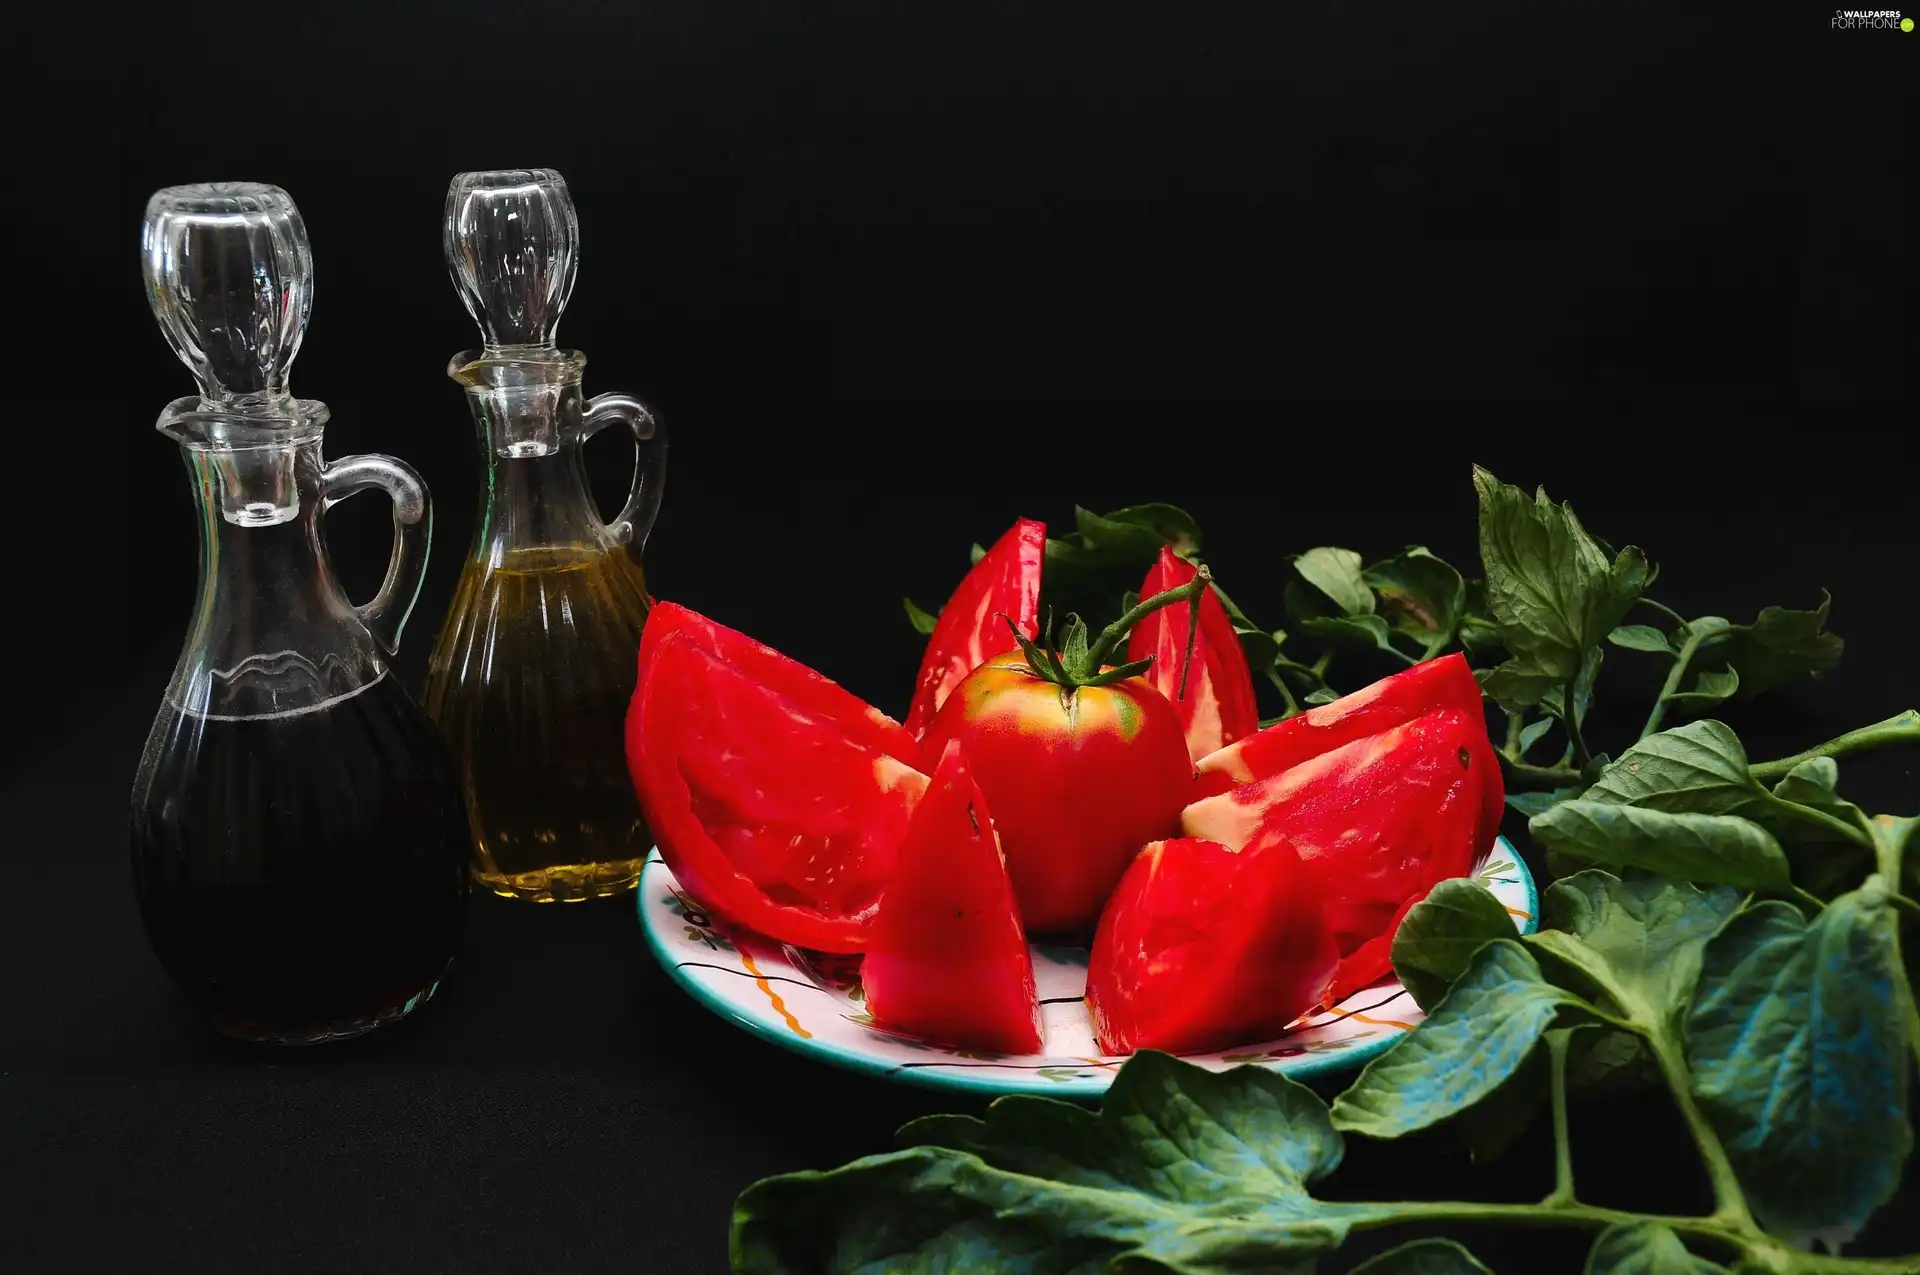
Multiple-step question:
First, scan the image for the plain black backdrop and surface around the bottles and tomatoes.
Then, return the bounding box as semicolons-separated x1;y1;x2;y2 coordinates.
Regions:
0;2;1920;1271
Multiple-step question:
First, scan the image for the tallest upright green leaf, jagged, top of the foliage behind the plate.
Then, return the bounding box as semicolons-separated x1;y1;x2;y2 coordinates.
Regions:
1473;465;1647;682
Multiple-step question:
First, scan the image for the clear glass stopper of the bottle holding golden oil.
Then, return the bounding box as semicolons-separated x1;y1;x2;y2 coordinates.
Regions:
442;169;580;349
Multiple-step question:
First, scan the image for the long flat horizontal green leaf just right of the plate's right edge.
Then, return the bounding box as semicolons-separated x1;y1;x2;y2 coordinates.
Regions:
1526;797;1789;889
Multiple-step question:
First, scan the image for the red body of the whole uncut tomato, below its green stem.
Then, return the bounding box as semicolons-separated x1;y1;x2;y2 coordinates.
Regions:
922;657;1192;939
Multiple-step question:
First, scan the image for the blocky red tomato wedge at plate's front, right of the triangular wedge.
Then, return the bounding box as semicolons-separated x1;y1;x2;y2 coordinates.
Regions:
1087;837;1336;1054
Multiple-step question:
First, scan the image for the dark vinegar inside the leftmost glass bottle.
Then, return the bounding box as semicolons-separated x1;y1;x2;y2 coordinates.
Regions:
132;676;468;1045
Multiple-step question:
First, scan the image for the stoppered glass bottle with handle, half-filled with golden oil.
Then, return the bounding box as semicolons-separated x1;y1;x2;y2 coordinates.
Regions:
426;169;666;902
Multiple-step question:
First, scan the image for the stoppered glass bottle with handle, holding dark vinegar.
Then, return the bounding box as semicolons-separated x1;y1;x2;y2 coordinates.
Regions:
131;182;468;1045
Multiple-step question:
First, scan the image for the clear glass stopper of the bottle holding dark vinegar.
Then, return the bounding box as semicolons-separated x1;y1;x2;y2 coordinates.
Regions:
140;182;313;403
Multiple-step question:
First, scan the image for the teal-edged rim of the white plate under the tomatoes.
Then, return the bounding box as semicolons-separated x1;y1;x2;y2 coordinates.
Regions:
634;835;1540;1098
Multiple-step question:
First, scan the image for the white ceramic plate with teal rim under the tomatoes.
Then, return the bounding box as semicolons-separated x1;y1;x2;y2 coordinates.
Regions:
637;837;1540;1096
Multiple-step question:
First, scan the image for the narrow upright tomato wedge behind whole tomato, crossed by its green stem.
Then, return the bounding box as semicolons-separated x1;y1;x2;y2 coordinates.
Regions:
1127;547;1260;760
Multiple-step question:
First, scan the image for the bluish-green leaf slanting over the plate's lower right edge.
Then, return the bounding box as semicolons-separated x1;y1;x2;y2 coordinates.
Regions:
1332;939;1592;1139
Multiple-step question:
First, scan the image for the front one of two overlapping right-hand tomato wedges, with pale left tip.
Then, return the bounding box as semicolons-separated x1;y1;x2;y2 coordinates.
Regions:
1181;705;1486;956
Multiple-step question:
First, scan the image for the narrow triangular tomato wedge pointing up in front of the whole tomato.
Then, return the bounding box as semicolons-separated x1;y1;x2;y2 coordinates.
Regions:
860;739;1041;1054
